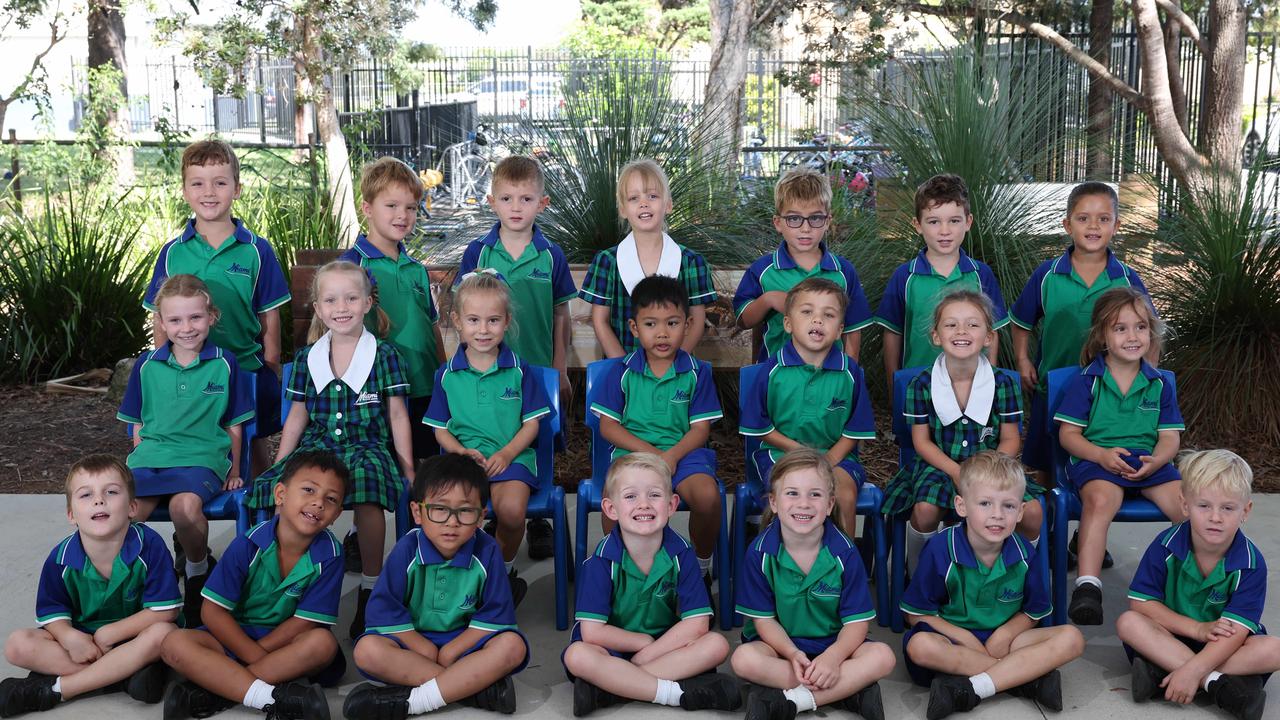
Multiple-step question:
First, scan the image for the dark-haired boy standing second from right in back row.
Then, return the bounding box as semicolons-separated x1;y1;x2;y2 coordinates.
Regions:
876;176;1009;384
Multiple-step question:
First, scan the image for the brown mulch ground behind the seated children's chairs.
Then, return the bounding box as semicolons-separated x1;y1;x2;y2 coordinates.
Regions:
0;387;1280;493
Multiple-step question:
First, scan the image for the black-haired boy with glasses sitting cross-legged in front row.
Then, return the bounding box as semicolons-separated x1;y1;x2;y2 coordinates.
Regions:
342;454;529;720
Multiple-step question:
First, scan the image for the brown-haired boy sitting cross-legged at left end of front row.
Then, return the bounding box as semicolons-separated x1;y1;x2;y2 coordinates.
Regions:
0;455;182;717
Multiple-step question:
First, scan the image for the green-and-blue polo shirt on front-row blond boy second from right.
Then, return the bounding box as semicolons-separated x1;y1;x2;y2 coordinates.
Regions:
901;523;1053;630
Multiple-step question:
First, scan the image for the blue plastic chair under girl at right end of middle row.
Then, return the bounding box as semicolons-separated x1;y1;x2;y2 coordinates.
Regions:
1044;368;1178;625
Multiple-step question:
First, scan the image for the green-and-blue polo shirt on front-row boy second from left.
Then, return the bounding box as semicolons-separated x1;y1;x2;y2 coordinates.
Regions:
200;515;343;628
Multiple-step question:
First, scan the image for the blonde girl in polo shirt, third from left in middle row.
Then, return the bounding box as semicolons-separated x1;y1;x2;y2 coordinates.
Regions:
422;272;552;606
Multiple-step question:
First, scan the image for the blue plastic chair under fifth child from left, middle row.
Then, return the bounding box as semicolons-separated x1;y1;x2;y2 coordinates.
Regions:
730;364;890;628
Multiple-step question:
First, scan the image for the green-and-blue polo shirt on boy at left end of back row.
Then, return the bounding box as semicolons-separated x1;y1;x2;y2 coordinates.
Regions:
142;218;291;372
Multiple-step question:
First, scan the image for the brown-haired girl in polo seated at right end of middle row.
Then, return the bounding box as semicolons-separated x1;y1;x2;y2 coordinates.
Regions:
1053;287;1187;625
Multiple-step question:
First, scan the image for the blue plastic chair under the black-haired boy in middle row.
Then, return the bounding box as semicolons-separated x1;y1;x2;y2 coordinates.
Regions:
573;357;733;630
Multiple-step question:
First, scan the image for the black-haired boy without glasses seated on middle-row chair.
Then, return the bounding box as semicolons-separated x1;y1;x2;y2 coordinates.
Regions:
590;275;723;582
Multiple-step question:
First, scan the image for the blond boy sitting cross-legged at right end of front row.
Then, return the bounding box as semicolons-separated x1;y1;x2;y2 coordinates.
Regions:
1116;450;1280;720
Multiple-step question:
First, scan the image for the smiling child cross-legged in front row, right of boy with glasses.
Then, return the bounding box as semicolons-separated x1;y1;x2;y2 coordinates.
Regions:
561;452;742;717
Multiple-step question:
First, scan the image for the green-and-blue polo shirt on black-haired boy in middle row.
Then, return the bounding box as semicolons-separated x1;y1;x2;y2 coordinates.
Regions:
591;348;724;459
